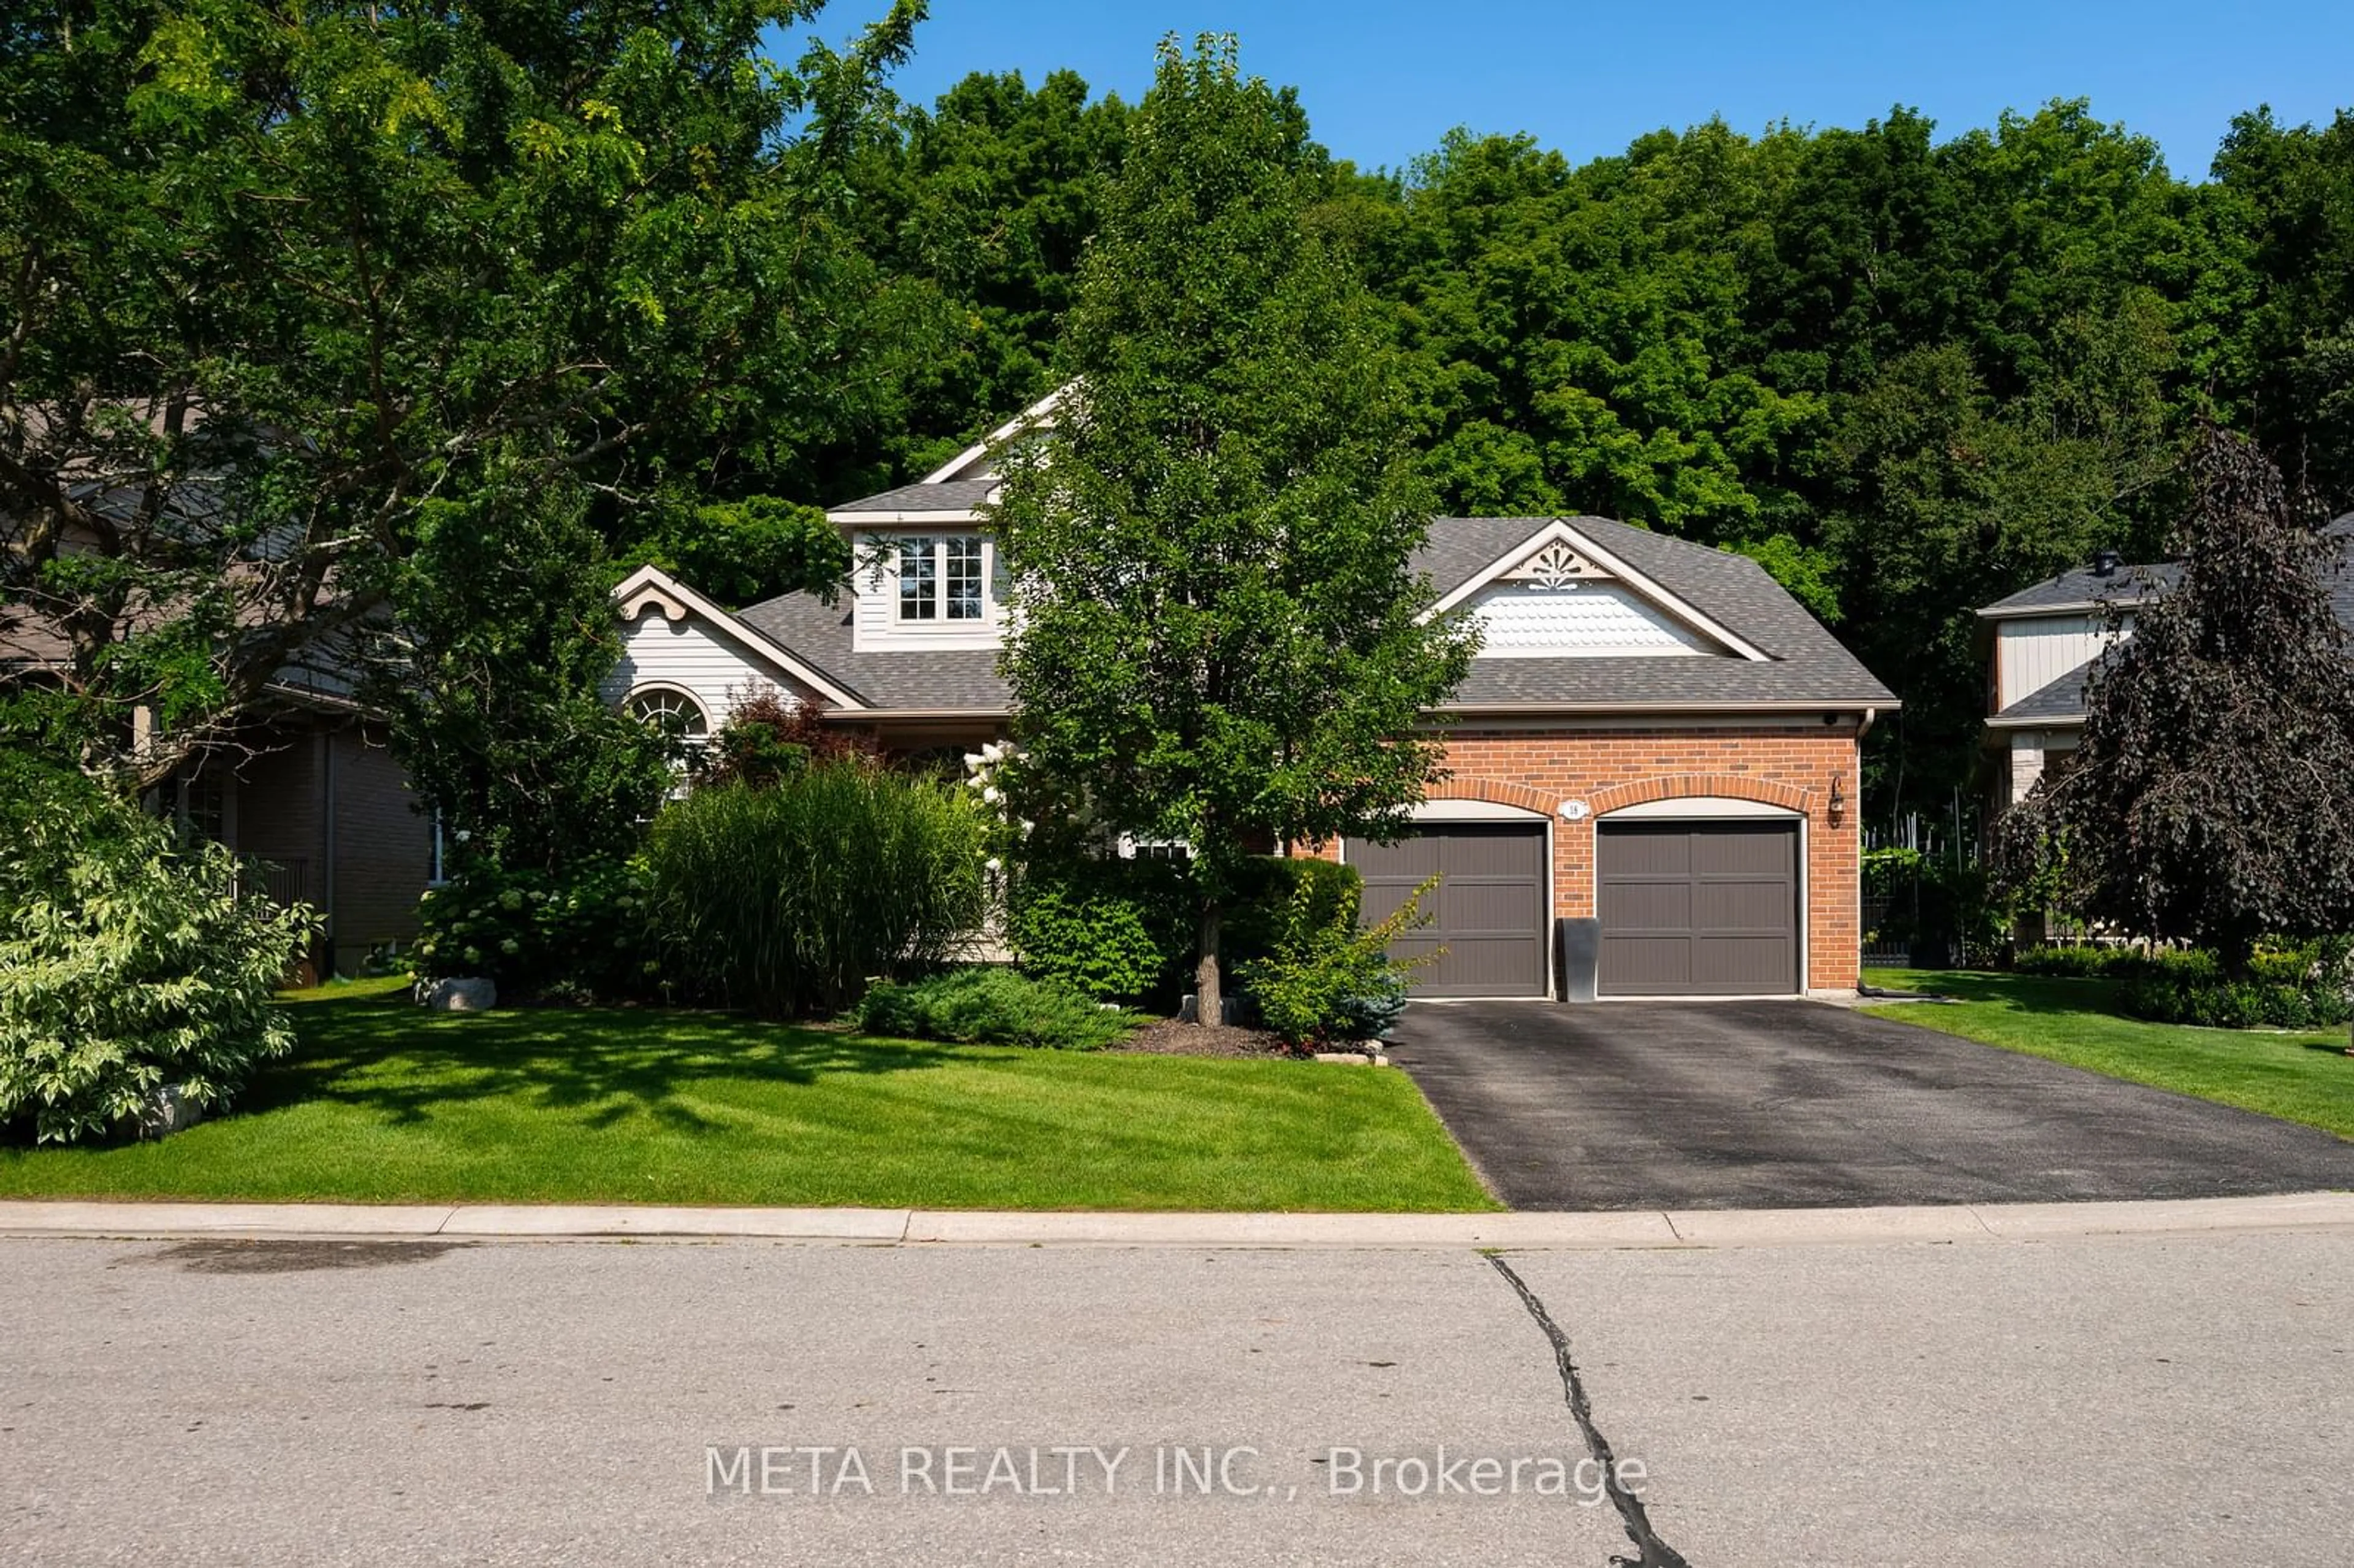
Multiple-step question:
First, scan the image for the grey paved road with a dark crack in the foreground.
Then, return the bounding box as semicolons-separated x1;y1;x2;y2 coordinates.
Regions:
0;1229;2354;1568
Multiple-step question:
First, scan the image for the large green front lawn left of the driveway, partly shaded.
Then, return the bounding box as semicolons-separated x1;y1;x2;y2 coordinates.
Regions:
0;982;1497;1210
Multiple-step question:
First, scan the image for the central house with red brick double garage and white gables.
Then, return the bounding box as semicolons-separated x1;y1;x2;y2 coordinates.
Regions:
610;398;1897;999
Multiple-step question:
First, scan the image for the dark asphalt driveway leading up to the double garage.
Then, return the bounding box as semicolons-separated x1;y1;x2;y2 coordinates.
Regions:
1391;1000;2354;1208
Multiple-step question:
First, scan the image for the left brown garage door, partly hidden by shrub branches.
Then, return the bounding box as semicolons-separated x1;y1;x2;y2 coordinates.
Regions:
1344;821;1547;996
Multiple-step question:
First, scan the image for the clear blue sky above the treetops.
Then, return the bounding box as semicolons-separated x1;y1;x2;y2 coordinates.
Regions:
856;0;2354;179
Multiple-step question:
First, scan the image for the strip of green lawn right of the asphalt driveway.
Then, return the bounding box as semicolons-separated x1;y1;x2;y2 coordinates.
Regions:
1864;970;2354;1137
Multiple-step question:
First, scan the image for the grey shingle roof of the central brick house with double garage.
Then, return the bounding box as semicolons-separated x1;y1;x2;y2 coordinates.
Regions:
739;506;1897;711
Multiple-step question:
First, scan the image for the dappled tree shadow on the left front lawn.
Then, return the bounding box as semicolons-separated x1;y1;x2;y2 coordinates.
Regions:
265;991;989;1132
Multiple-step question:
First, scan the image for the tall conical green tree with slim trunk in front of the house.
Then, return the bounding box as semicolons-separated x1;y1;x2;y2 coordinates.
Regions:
996;37;1471;1022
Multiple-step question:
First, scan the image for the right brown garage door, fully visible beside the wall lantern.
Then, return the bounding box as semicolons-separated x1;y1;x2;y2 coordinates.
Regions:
1596;821;1799;996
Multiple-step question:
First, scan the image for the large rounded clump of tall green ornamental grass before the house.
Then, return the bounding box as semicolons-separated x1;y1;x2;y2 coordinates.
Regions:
647;763;984;1017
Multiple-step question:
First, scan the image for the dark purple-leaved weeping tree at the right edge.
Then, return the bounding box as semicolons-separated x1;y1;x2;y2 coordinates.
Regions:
2006;431;2354;975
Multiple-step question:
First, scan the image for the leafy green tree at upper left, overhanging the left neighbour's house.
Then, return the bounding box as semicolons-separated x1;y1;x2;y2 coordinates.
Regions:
0;0;923;789
